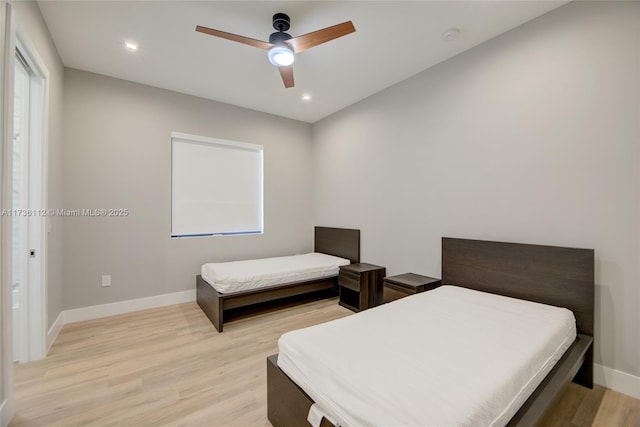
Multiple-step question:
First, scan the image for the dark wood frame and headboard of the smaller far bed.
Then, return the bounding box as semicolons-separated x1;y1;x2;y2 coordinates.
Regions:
196;227;360;332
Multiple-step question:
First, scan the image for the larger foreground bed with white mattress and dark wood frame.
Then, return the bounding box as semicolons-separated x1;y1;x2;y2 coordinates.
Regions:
267;238;593;427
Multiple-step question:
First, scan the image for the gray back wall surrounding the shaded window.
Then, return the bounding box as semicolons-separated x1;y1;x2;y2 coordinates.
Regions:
63;69;313;309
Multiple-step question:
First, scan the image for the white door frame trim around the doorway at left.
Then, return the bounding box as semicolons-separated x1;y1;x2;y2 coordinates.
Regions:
0;5;49;427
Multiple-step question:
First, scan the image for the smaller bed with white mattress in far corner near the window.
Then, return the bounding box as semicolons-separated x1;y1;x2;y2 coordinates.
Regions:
196;227;360;332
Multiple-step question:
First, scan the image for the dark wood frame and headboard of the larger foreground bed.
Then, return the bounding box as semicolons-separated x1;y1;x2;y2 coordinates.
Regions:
267;237;594;427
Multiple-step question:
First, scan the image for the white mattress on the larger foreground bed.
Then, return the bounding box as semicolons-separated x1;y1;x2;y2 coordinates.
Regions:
278;286;576;427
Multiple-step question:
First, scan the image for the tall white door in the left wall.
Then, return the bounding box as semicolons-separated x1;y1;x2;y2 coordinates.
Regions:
11;45;46;362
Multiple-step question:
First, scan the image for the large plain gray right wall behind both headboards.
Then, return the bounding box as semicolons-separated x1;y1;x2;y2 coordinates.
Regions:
313;2;640;376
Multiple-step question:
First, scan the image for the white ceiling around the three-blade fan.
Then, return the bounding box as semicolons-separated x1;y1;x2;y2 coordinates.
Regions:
38;0;567;123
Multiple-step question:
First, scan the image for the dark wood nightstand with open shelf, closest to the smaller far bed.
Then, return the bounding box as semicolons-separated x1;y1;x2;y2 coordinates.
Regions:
338;263;386;312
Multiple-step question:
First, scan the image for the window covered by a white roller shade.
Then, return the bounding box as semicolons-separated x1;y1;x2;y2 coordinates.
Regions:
171;132;263;237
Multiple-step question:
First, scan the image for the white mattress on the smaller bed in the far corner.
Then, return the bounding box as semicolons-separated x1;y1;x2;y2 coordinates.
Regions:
201;252;350;294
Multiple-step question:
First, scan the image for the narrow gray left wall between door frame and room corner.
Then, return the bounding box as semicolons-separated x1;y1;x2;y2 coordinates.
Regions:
13;1;64;332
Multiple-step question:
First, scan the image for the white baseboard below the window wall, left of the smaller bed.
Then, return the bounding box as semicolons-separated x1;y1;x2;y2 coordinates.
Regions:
62;289;196;324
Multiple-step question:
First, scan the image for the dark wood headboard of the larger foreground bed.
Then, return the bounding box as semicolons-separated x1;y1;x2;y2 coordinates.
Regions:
442;237;594;336
